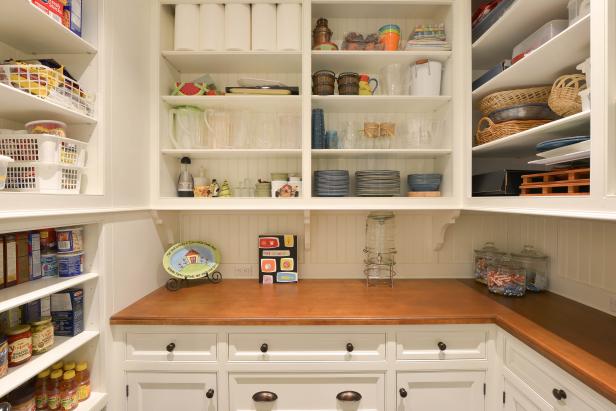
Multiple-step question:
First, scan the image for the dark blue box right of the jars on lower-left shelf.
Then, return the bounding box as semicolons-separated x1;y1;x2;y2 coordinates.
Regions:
51;288;84;337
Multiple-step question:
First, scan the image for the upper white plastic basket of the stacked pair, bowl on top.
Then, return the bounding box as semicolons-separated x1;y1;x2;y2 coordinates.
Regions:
0;134;88;167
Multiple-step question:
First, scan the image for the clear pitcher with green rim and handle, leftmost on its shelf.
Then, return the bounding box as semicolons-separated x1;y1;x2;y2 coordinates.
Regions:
169;106;205;149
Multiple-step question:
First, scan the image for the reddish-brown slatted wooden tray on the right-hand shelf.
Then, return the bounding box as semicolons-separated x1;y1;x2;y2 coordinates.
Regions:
520;168;590;196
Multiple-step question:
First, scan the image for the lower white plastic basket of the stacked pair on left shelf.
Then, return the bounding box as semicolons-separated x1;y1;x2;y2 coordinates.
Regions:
5;162;83;194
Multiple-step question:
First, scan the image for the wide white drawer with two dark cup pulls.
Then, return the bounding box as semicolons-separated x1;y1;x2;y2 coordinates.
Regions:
229;373;385;411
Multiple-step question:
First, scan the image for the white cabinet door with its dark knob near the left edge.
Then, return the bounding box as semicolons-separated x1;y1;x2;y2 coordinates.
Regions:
396;371;485;411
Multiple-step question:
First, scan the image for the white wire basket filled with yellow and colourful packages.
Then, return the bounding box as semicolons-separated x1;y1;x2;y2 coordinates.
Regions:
0;64;94;116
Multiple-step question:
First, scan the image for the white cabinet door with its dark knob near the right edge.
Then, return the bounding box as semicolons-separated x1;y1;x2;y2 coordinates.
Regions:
127;372;218;411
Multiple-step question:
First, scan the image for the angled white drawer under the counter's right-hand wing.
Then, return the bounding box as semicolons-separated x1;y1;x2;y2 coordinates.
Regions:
505;338;601;411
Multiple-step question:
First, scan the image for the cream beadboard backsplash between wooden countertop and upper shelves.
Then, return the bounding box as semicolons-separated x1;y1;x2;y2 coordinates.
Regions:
179;212;616;314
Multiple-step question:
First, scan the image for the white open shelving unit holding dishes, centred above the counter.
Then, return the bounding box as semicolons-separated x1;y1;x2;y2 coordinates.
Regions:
152;0;464;210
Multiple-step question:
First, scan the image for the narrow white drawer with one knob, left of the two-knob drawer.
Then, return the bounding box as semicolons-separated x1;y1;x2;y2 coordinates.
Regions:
126;332;216;361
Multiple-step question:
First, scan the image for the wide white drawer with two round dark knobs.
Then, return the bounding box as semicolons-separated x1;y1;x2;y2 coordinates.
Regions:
229;333;385;361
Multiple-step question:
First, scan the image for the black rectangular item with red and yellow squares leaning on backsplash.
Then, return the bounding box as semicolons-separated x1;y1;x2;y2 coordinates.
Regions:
259;234;298;284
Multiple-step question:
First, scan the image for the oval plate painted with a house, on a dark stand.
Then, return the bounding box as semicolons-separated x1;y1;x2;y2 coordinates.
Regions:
163;241;220;280
